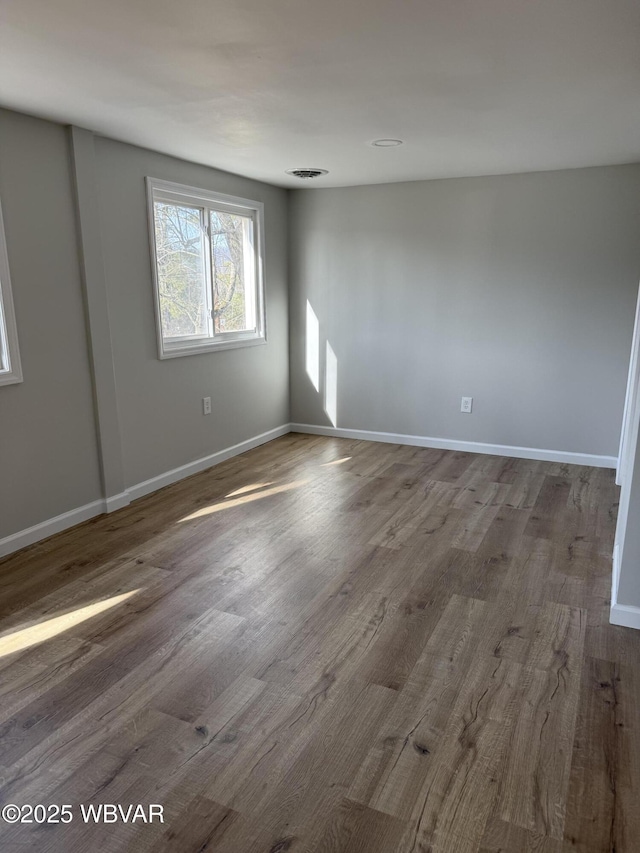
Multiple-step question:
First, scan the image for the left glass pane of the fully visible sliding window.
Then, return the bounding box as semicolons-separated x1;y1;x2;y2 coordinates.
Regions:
154;201;210;338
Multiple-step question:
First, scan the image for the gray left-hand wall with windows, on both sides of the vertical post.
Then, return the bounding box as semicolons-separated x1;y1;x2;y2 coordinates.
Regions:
0;110;289;539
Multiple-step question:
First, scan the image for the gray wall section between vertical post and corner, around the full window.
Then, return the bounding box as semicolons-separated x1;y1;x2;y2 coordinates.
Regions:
96;137;289;486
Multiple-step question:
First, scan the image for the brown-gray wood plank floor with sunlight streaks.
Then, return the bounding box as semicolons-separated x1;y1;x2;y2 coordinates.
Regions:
0;435;640;853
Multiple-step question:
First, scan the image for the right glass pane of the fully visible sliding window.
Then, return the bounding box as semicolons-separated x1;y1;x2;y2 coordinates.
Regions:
209;210;256;333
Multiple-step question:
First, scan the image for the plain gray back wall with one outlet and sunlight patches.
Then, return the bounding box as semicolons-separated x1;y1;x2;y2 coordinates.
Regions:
290;165;640;456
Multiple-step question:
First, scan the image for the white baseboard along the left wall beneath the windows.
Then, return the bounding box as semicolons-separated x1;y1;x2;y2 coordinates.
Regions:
0;424;291;557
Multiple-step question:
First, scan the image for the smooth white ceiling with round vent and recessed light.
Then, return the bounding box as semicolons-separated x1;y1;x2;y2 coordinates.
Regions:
0;0;640;186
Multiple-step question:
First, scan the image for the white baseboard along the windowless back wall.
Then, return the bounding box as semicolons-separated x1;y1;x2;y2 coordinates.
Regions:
291;424;617;468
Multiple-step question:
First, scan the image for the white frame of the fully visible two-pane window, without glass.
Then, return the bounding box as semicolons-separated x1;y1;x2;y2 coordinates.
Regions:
146;177;267;359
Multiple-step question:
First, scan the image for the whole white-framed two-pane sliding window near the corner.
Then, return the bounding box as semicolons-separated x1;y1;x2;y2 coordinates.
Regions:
147;178;266;358
